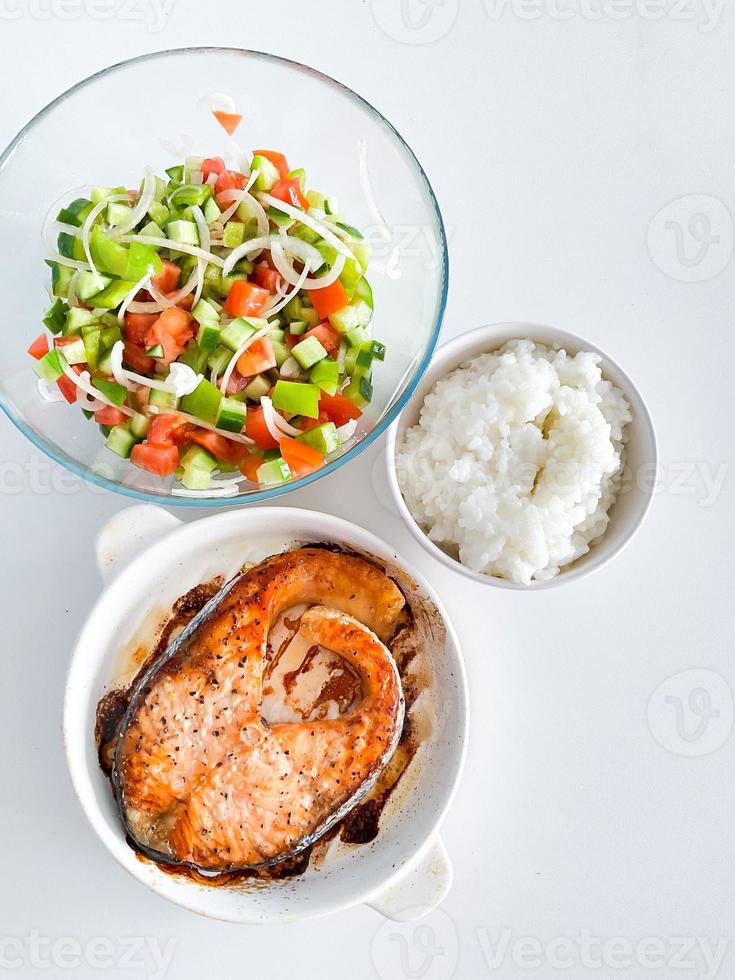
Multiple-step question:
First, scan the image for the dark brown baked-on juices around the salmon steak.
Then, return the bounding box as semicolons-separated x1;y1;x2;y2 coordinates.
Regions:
95;544;420;887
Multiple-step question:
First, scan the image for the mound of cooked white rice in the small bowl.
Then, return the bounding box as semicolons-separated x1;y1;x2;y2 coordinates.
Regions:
396;340;631;584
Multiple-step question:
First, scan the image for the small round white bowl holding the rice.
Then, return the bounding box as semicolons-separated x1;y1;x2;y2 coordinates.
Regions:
386;322;658;592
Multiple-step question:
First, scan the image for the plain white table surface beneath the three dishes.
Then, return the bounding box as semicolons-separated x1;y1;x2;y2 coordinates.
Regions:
0;0;735;980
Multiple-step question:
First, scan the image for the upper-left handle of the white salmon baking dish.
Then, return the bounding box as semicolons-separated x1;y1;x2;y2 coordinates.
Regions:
94;504;183;585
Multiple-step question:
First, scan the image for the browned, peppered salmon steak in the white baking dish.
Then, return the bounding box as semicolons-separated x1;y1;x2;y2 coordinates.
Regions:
112;548;404;873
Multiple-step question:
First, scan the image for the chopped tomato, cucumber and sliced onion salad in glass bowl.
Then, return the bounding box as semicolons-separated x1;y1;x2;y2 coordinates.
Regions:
28;144;385;496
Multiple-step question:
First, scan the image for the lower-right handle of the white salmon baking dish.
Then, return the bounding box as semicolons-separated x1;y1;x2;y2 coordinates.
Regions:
366;836;453;922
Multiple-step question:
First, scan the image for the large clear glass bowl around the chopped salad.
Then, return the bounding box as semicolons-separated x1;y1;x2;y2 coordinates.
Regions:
0;48;447;506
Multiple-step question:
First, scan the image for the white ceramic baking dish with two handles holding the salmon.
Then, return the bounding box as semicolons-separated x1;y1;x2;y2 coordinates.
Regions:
64;504;468;923
